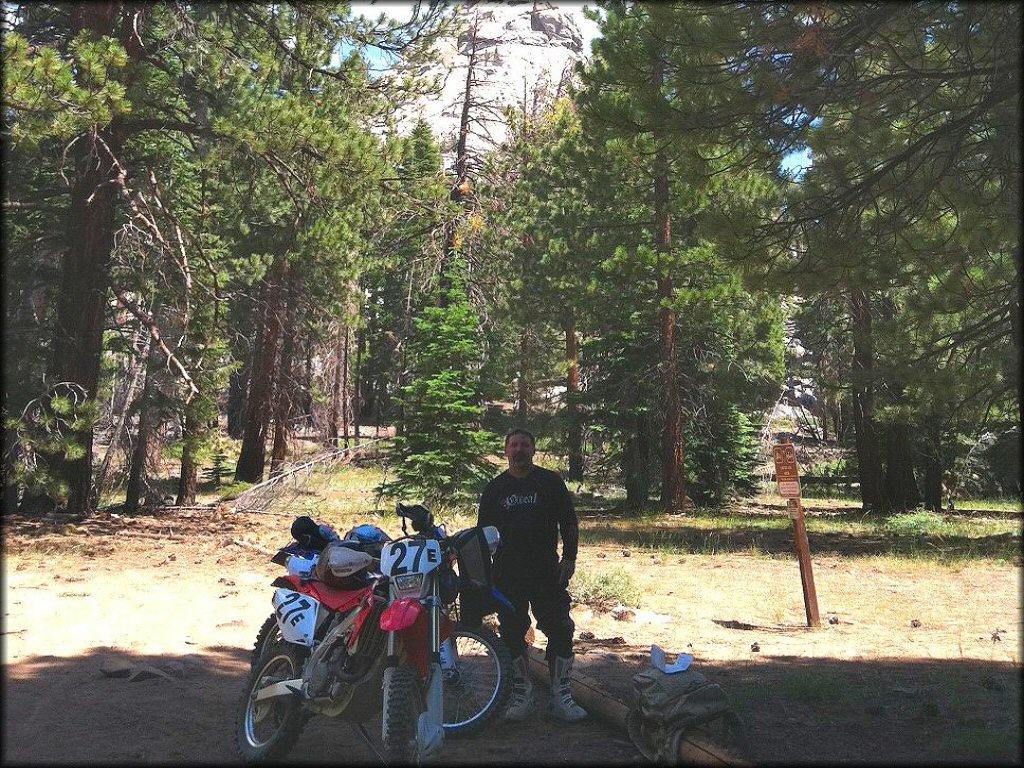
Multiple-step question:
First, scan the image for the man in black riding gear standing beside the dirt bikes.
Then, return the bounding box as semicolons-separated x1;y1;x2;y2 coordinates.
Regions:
477;429;587;721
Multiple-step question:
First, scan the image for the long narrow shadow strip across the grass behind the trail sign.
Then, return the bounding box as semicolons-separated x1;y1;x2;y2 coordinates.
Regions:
580;515;1022;564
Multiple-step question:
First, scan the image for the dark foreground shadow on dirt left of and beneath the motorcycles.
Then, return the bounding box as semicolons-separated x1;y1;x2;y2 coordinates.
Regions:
3;647;640;765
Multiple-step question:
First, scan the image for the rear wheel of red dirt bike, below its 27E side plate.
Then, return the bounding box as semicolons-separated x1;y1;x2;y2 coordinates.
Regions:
234;642;307;763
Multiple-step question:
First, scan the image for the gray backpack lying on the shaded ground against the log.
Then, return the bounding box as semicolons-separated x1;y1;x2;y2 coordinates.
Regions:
627;668;745;765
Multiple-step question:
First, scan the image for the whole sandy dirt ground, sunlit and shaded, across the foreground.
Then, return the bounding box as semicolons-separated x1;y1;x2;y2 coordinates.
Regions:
2;509;1021;764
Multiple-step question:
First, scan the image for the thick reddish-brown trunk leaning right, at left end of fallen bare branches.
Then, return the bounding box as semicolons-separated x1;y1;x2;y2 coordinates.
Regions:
234;254;288;482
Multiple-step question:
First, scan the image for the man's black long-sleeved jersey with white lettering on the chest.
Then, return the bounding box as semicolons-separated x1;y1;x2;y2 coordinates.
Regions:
477;466;580;580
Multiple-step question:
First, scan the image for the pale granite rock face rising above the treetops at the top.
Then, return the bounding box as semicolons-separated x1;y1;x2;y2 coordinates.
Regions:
401;2;585;168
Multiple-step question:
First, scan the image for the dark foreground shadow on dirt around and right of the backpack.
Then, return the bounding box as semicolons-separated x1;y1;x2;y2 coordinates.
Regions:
577;647;1021;765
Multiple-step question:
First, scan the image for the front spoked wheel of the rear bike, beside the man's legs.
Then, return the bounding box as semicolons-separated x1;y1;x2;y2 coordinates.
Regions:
443;627;512;737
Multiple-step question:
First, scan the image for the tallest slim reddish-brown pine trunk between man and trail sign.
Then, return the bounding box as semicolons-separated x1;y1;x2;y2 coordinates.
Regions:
653;139;686;512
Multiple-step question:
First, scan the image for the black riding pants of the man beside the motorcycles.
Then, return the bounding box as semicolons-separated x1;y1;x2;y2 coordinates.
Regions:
496;574;575;660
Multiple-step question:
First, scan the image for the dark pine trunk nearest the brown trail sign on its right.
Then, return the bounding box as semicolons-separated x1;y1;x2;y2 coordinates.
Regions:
850;290;888;513
